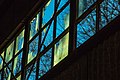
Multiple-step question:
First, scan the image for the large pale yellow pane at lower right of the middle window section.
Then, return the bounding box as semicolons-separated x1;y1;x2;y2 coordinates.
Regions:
54;33;69;66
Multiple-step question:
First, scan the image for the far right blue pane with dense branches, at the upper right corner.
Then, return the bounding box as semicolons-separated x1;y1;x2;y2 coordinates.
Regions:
100;0;120;29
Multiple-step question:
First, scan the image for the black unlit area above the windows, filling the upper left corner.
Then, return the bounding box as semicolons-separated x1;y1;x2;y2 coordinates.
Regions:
0;0;38;44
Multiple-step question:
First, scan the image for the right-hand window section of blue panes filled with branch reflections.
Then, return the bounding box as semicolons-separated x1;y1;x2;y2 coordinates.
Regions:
76;0;120;47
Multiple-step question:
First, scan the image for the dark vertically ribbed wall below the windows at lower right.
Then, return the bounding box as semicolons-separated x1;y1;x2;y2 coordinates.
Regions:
53;28;120;80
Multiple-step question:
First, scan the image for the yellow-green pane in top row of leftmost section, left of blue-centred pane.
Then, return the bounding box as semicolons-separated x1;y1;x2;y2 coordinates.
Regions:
5;41;14;63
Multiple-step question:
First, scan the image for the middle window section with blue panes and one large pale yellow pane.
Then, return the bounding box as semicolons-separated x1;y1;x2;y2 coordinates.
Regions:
26;0;70;80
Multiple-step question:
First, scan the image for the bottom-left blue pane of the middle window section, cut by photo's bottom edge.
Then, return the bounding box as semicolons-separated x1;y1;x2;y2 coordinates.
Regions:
26;63;36;80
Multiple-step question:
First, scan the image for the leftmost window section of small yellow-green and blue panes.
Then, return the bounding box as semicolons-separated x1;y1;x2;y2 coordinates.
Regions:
0;29;24;80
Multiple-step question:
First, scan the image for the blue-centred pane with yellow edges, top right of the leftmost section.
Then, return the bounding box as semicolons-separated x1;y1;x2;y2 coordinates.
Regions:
15;30;25;53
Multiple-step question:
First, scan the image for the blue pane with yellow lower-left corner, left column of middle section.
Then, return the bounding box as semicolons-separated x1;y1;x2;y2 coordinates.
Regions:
27;36;39;63
